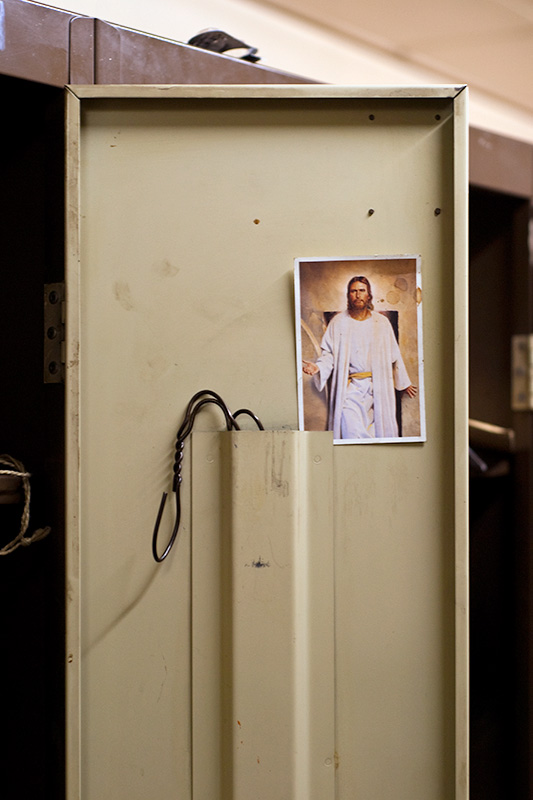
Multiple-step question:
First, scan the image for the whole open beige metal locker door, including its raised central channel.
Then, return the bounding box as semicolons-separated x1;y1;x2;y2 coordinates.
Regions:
66;86;468;800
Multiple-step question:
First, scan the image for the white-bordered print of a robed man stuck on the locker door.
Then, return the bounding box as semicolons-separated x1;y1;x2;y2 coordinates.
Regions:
295;255;426;444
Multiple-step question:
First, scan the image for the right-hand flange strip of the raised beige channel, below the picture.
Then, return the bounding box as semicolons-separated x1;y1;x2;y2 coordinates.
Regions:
293;433;335;800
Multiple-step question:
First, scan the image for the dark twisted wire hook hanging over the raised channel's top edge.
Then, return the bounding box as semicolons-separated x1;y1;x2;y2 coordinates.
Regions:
152;389;264;564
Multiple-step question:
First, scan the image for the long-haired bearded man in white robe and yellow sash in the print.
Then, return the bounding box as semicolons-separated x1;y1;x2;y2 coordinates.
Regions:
303;275;417;439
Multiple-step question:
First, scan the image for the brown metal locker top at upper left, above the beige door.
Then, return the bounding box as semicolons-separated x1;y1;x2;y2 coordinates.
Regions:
0;0;314;86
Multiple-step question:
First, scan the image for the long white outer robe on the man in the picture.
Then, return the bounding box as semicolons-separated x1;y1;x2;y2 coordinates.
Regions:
316;310;411;439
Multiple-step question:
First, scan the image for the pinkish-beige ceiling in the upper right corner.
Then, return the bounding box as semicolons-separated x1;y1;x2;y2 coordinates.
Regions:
269;0;533;112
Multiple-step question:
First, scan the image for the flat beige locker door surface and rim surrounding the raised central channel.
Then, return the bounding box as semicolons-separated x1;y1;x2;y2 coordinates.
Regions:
67;87;467;800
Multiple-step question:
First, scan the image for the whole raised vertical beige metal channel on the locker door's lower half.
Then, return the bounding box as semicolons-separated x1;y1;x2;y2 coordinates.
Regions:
192;431;334;800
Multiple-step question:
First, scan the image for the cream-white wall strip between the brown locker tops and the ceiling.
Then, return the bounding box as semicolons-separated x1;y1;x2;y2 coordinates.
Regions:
42;0;533;142
